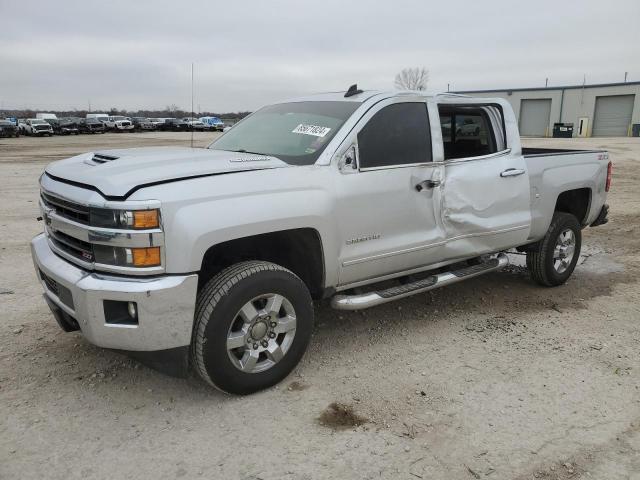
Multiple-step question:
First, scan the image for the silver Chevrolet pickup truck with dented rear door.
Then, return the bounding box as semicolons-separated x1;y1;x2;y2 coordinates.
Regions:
31;86;611;394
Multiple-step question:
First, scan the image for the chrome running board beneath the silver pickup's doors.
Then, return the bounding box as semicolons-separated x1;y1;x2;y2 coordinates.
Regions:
331;253;509;310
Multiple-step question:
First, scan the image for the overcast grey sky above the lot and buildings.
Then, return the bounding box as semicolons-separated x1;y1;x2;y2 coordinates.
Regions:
0;0;640;112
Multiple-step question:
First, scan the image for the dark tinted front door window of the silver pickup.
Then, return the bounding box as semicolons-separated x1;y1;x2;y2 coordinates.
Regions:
358;103;431;168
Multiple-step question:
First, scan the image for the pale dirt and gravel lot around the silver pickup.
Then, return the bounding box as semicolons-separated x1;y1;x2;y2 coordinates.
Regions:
0;133;640;480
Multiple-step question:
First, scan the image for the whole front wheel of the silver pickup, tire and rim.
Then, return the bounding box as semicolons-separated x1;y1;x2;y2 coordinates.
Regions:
191;261;313;395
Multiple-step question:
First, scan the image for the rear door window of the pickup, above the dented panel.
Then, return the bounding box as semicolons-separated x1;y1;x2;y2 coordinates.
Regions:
439;105;502;160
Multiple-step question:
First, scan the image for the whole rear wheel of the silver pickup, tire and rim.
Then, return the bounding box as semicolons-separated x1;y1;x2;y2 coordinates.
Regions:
527;212;582;287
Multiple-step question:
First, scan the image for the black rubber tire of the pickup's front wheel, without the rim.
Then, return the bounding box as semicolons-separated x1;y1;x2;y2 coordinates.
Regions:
191;261;313;395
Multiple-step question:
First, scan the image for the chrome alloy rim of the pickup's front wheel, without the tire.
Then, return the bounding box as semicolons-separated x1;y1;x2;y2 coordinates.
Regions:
227;293;296;373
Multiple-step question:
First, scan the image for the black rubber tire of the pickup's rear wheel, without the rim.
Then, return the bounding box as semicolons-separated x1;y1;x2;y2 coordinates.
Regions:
527;212;582;287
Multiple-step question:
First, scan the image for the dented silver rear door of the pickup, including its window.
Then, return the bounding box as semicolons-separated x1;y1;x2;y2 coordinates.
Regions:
438;103;531;259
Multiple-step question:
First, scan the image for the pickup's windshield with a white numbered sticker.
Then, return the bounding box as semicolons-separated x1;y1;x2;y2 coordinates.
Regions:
209;102;360;165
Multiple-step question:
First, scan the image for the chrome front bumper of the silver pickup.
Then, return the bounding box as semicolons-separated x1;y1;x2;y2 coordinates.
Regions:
31;234;198;352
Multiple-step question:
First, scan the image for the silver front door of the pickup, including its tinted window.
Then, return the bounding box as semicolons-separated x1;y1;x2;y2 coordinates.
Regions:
336;98;444;286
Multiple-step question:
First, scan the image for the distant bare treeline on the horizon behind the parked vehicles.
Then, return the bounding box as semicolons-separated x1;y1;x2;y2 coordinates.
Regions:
0;105;251;122
